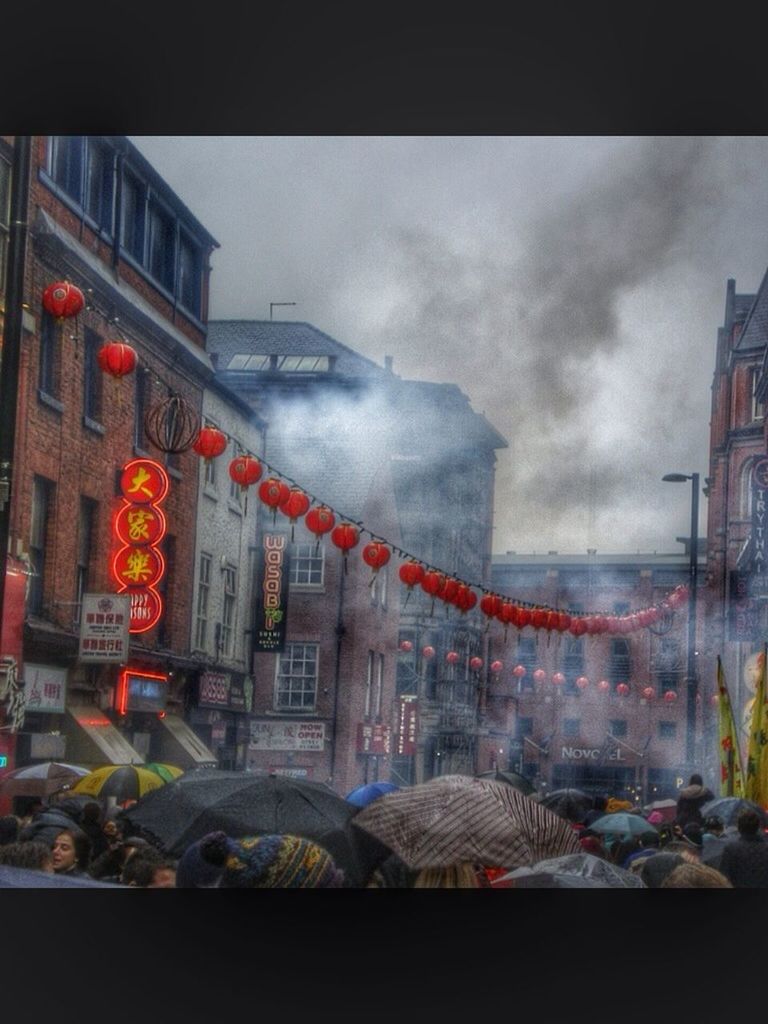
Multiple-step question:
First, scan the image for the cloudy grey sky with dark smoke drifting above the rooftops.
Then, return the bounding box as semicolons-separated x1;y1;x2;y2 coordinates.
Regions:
130;135;768;554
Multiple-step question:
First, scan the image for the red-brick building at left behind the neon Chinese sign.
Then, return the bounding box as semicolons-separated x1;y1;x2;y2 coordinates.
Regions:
0;135;222;790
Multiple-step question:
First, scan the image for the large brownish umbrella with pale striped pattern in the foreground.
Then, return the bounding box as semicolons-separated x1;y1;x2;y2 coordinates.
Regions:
354;775;582;869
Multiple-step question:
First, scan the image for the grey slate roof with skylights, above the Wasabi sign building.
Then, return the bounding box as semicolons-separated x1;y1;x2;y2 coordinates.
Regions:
207;321;389;377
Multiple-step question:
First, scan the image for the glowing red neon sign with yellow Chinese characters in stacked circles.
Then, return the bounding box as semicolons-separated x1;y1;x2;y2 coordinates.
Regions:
112;459;170;633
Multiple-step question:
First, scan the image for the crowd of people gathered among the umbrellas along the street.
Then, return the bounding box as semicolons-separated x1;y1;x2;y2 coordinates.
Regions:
0;774;768;889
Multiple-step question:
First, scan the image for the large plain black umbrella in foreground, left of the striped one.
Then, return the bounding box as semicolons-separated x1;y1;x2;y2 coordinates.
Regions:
121;770;391;886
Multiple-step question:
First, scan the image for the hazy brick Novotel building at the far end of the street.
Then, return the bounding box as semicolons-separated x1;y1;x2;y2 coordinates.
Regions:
487;545;713;803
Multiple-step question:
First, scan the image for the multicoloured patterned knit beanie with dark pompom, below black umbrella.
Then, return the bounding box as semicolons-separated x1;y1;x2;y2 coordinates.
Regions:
200;833;344;889
